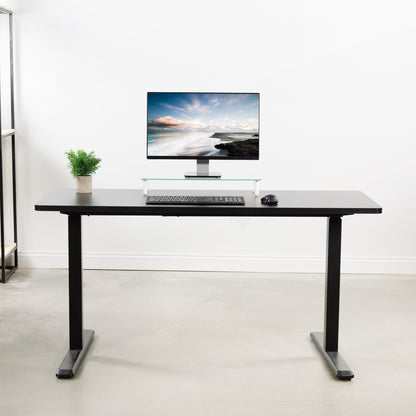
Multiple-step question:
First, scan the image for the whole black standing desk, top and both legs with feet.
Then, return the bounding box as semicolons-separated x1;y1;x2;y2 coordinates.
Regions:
35;189;381;380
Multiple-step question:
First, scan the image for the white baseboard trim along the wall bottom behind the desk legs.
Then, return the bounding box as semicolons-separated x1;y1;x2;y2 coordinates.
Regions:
19;252;416;275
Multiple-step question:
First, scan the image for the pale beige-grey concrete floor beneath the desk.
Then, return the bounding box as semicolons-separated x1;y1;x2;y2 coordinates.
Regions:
0;269;416;416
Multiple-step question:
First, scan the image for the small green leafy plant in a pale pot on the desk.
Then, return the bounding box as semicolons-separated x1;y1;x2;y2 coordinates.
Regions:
65;150;101;194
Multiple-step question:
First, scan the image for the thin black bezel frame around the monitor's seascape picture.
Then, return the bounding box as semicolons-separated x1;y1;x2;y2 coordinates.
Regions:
146;91;260;160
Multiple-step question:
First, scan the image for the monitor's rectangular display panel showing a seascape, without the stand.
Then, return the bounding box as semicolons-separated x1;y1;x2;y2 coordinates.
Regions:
147;92;259;159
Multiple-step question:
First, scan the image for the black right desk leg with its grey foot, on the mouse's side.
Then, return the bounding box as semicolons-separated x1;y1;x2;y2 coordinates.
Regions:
311;217;354;380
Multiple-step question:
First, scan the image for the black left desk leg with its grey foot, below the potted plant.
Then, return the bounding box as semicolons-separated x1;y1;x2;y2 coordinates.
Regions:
56;214;94;378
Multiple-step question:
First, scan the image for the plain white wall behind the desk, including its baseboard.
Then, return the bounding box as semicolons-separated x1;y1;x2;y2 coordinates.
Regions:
3;0;416;274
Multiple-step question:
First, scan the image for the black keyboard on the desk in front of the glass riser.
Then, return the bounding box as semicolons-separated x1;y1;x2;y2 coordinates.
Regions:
146;195;245;205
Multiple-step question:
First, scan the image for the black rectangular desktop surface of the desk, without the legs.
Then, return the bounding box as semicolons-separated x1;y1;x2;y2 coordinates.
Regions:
35;189;382;217
